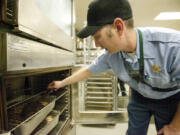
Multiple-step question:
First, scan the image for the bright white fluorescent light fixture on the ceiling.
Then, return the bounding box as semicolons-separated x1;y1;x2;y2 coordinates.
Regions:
154;12;180;20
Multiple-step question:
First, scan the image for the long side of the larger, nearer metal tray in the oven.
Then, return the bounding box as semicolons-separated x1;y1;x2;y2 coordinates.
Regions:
12;96;55;135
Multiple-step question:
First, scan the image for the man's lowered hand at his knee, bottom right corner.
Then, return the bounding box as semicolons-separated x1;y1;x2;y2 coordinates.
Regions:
157;125;180;135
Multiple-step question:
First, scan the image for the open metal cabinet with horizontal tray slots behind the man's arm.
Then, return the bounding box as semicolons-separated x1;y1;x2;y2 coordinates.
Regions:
72;67;129;124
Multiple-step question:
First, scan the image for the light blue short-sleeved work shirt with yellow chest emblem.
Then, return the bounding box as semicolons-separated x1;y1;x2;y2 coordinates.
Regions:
88;27;180;99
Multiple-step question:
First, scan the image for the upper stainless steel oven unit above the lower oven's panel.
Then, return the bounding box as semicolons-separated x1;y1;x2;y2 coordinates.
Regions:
2;0;74;51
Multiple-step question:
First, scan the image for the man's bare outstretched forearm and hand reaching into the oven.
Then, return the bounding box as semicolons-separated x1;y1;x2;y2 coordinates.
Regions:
48;67;91;90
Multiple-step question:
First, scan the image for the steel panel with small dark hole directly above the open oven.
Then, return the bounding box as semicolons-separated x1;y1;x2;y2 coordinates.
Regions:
0;34;75;72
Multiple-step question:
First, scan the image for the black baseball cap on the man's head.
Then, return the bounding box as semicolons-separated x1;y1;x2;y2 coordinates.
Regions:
77;0;132;38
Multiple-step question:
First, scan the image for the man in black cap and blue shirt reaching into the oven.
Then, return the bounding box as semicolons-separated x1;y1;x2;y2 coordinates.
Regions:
48;0;180;135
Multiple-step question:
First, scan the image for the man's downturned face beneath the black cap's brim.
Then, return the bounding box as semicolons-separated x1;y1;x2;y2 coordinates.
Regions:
93;25;122;54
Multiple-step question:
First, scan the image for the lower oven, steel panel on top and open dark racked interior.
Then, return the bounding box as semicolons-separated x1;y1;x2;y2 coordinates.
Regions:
0;33;74;135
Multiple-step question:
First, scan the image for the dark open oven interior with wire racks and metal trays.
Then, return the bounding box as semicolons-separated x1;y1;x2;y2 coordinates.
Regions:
3;69;71;135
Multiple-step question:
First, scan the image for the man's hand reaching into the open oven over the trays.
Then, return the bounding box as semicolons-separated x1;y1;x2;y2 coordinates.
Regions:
48;81;64;91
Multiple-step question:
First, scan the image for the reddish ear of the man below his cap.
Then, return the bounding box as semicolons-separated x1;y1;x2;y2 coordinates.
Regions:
113;18;124;35
